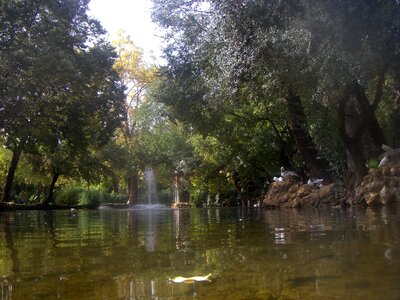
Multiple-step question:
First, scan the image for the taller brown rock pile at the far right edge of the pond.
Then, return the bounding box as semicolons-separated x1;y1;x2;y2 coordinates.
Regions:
352;162;400;206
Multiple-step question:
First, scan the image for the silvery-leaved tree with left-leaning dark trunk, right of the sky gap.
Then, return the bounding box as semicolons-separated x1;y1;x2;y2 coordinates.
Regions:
150;1;331;178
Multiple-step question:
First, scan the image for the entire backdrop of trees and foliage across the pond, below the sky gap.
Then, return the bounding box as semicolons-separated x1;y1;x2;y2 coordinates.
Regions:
0;0;400;206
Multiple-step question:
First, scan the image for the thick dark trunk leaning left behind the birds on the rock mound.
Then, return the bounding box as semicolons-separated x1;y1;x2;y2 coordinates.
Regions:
286;90;333;182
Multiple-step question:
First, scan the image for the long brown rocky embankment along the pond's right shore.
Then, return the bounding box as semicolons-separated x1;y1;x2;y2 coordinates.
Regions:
263;145;400;207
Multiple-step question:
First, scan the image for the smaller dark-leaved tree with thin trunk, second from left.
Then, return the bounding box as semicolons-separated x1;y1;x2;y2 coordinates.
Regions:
37;45;124;203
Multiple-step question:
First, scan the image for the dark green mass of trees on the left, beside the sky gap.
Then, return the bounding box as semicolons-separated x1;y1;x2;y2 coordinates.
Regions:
0;0;123;202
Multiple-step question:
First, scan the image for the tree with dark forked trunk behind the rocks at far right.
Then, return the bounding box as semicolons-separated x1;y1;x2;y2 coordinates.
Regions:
305;1;400;187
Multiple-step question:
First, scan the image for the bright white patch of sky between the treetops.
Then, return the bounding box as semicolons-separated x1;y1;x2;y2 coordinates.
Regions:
89;0;161;58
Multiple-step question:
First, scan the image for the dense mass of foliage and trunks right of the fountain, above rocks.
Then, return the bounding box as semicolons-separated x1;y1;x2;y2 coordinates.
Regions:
149;0;400;204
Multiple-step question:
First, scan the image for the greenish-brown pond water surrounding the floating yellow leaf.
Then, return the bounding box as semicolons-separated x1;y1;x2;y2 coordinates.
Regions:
0;208;400;300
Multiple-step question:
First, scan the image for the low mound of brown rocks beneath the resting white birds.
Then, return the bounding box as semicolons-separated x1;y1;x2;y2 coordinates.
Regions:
263;180;346;207
